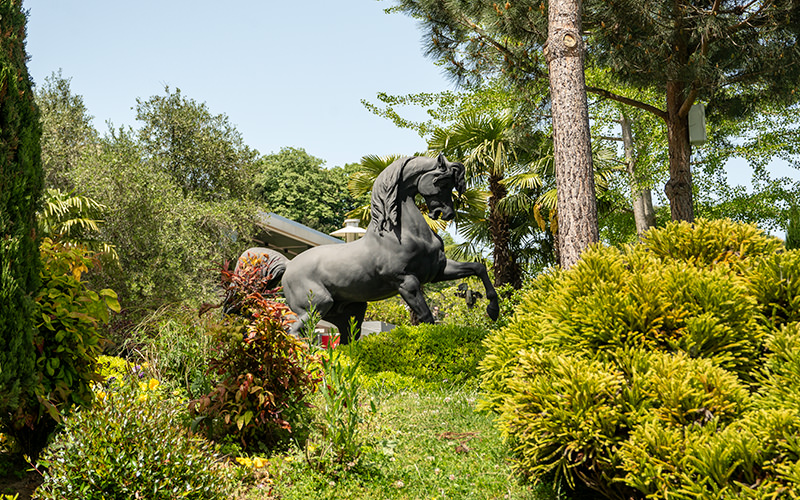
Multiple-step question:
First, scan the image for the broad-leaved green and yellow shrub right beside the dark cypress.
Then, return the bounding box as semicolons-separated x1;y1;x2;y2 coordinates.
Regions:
9;238;119;456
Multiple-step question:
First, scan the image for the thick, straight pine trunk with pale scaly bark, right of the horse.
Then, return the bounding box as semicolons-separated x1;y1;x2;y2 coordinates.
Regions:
545;0;599;269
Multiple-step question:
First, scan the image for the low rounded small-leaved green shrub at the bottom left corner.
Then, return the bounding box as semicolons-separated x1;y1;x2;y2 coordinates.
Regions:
33;380;231;500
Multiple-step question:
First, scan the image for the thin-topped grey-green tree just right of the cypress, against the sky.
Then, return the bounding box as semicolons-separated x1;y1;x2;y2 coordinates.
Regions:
36;71;98;191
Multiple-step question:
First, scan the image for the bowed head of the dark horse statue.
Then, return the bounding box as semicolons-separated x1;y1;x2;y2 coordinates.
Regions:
417;153;467;220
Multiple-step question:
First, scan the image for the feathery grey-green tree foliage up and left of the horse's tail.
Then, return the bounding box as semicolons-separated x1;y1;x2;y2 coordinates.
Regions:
73;127;255;310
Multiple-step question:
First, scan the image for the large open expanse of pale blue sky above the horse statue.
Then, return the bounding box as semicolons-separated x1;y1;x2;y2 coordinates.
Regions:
23;0;453;167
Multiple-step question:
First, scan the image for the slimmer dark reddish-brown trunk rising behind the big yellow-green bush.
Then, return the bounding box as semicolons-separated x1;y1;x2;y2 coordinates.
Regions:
664;82;694;222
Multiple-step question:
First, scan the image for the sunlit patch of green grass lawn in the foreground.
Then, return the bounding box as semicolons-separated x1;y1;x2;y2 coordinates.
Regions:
234;380;565;500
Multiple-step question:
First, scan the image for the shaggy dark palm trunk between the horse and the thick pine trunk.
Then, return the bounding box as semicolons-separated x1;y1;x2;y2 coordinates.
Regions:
489;176;522;289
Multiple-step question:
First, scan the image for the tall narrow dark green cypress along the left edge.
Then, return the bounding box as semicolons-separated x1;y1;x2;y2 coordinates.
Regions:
0;0;43;429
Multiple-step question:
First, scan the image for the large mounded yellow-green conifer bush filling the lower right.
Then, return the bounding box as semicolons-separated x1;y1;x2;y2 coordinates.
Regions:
480;220;800;499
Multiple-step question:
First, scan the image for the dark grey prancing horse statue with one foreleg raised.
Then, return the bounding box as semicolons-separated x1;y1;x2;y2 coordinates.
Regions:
228;154;500;344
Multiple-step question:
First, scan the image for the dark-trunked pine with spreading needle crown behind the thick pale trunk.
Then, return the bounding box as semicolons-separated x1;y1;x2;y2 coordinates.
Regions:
392;0;800;220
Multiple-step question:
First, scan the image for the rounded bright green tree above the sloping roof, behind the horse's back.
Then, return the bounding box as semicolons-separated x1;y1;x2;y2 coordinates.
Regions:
253;148;355;234
